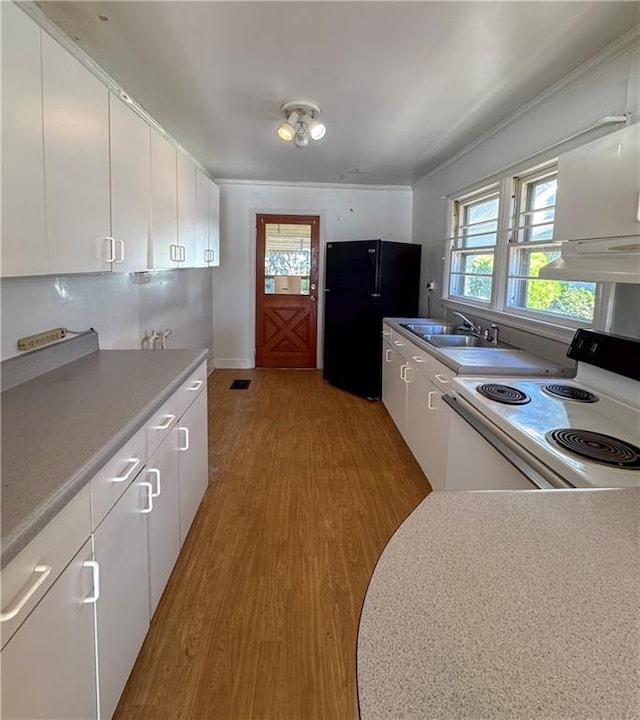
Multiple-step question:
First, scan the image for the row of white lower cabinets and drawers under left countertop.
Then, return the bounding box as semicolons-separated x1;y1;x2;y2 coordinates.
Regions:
0;363;209;720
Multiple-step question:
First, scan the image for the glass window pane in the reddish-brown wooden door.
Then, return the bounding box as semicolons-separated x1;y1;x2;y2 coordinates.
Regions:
264;223;311;295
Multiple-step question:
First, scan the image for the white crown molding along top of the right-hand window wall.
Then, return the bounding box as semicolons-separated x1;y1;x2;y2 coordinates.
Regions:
413;25;640;190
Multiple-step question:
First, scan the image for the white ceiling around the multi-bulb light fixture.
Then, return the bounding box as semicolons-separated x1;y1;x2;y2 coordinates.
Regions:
39;1;640;184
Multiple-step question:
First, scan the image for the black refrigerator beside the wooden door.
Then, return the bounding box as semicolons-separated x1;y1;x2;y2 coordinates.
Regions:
323;240;422;400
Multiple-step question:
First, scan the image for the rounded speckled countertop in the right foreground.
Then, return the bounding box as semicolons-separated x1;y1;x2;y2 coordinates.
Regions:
358;489;640;720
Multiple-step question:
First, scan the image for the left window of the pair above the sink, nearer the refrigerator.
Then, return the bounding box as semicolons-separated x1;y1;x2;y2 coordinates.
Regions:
449;186;500;303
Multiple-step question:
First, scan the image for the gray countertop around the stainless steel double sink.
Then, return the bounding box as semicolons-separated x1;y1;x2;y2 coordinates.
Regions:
384;318;575;377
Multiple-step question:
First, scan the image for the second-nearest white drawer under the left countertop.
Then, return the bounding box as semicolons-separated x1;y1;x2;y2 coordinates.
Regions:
91;428;147;530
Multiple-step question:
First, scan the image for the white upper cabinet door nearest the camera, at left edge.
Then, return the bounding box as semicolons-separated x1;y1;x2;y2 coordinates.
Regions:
0;2;47;277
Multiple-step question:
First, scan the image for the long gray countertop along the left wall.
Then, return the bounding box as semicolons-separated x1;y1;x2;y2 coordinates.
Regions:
1;350;207;567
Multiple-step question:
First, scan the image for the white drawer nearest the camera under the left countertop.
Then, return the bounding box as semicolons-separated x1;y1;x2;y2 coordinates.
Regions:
0;484;91;647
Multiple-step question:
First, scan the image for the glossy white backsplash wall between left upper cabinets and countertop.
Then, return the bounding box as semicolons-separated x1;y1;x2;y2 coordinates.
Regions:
0;269;213;367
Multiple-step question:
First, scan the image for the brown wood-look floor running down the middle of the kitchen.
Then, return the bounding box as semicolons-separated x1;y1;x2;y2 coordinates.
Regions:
115;370;430;720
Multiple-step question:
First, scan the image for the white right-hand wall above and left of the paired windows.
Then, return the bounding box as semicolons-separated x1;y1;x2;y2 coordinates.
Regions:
413;35;640;334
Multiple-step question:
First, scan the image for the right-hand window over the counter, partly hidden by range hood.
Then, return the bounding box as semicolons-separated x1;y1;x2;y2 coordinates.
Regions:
505;166;596;322
